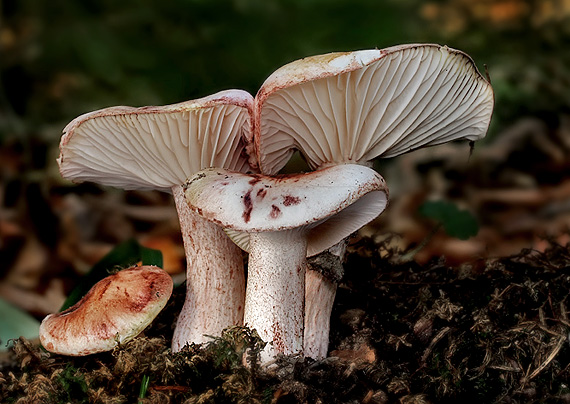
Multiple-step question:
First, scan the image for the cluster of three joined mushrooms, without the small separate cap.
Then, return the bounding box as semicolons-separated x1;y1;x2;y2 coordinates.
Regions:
51;44;493;362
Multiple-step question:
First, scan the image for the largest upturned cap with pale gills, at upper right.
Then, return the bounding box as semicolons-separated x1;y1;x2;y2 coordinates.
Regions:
250;44;493;174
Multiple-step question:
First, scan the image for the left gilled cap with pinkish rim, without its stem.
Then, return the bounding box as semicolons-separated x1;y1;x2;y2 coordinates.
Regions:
58;90;253;192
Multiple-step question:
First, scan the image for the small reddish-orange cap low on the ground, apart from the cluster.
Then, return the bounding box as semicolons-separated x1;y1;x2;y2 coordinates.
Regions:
40;266;172;356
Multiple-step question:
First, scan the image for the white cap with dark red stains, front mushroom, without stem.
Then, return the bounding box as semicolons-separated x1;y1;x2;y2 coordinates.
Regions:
184;164;388;256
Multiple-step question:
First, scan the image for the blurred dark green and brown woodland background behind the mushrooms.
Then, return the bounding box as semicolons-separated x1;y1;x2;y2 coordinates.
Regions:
0;0;570;332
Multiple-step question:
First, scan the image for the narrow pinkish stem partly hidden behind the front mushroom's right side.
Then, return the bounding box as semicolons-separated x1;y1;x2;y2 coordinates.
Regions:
303;239;347;359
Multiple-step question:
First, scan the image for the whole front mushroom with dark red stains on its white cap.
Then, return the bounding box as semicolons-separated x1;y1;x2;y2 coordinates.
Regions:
184;164;388;363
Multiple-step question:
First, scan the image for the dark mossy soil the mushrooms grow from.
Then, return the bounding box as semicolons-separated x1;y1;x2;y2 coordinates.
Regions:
0;238;570;404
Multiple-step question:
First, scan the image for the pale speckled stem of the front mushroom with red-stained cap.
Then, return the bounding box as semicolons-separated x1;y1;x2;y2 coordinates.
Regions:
244;230;307;363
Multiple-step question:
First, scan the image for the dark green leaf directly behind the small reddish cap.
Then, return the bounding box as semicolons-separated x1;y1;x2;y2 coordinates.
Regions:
60;239;162;311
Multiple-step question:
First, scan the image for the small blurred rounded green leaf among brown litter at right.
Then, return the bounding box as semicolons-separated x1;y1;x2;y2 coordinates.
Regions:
419;201;479;240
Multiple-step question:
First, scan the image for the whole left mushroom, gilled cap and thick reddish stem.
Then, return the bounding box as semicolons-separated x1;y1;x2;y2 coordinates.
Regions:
58;90;253;351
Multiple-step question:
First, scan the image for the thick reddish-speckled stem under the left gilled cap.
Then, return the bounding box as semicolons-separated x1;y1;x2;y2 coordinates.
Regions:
172;186;245;352
